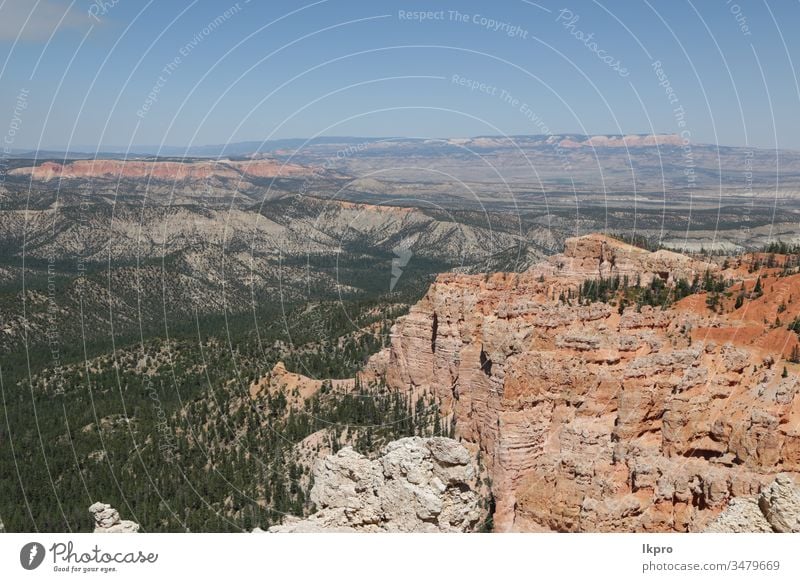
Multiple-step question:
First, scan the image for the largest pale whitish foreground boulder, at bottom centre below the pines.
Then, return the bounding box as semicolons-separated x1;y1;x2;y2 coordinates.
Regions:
269;437;488;533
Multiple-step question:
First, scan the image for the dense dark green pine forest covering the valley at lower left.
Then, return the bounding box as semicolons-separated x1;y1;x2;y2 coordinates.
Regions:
0;277;450;532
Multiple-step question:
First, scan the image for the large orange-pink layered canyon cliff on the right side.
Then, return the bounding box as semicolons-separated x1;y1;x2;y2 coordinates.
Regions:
367;235;800;531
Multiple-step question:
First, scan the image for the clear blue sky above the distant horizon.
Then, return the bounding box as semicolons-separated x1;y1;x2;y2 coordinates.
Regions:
0;0;800;149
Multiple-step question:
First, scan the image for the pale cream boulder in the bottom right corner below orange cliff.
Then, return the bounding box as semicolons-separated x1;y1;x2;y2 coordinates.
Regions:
706;474;800;533
